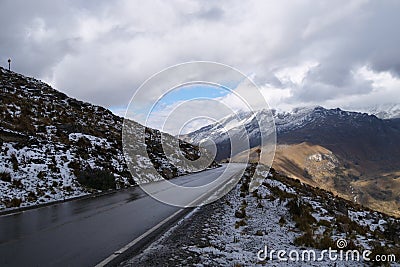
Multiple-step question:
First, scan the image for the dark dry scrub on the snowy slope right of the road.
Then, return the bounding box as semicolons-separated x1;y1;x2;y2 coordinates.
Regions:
234;164;400;260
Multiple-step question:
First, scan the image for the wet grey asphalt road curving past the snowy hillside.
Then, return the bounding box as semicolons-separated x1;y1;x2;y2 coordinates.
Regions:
0;164;243;266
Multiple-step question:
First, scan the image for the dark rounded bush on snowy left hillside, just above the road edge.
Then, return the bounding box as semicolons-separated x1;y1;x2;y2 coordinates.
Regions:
77;168;116;190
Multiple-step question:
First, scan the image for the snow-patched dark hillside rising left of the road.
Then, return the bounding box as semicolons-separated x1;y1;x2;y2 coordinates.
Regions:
0;68;212;209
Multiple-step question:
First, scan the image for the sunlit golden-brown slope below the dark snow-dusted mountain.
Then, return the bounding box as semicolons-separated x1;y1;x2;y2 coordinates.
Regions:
232;142;400;217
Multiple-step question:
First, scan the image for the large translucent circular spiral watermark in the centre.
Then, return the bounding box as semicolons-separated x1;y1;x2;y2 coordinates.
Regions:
122;61;276;207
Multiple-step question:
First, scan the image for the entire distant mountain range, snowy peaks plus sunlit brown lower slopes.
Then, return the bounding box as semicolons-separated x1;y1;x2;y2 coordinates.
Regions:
184;107;400;218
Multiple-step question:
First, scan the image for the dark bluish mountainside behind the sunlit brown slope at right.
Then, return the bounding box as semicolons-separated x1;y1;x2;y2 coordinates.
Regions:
277;107;400;172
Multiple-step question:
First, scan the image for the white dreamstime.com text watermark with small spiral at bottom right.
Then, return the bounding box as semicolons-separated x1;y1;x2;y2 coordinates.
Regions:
257;238;396;263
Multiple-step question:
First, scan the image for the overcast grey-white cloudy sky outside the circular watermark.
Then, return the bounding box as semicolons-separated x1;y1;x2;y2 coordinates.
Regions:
0;0;400;124
